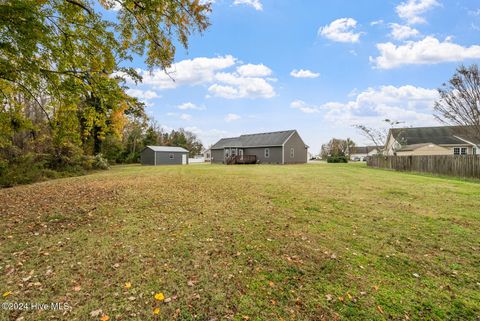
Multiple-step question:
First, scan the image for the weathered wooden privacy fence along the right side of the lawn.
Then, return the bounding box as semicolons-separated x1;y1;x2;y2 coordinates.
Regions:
367;155;480;179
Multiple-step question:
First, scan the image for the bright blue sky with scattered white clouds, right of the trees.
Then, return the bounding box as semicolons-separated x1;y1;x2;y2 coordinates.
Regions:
119;0;480;154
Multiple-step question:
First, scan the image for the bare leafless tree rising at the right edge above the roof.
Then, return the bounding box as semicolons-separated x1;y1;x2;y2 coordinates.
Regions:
434;64;480;140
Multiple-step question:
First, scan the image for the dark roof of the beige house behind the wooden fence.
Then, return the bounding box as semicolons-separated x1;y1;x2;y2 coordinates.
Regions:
390;126;480;145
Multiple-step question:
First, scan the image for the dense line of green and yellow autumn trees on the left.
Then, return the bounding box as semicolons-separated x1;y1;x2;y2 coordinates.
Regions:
0;0;210;185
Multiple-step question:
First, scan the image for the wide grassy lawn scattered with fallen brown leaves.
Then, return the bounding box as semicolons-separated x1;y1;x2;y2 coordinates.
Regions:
0;164;480;320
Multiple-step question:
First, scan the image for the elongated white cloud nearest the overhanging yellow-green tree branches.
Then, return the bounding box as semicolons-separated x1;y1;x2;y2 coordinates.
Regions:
140;55;236;89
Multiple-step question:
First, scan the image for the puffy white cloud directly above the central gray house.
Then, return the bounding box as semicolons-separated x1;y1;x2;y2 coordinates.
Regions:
208;72;275;99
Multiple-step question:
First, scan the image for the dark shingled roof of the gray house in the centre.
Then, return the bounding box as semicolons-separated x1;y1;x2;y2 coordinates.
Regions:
211;130;296;149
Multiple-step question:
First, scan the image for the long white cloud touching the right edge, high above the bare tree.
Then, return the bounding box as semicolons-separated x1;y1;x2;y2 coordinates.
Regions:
370;36;480;69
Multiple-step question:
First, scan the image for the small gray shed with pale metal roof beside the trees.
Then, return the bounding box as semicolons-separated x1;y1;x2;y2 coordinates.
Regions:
140;146;188;165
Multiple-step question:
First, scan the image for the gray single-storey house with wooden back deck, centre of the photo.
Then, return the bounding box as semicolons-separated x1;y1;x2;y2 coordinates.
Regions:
210;130;308;164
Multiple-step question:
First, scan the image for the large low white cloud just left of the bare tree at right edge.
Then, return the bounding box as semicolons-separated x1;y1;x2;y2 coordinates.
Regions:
321;85;438;128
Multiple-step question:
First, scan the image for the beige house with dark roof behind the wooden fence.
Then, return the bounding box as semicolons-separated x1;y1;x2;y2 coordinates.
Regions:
385;126;480;156
